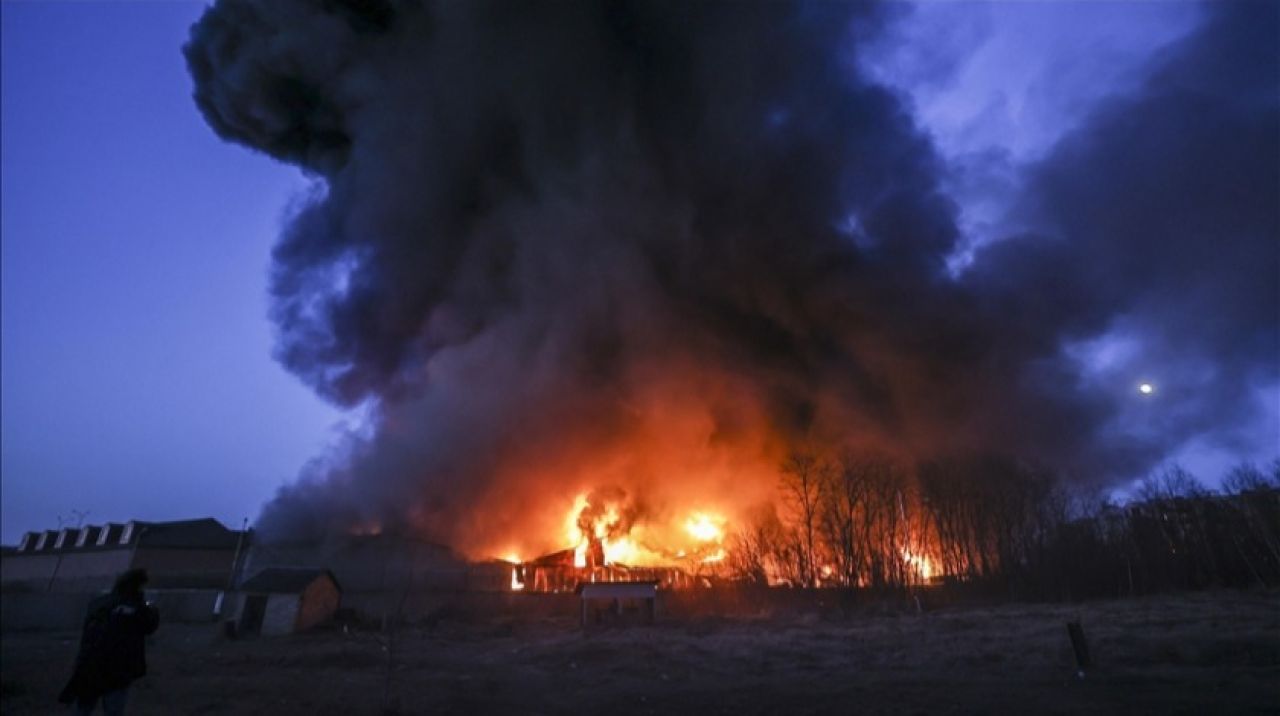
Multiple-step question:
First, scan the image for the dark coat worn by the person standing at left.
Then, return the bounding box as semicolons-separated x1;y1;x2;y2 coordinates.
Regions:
59;592;160;703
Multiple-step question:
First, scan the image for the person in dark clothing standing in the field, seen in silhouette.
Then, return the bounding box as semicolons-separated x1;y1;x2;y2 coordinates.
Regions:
58;569;160;716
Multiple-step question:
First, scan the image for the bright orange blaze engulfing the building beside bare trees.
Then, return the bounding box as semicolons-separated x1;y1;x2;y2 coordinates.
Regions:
471;397;942;592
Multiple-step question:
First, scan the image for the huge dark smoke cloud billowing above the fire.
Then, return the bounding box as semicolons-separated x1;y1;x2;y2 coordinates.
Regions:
186;0;1277;545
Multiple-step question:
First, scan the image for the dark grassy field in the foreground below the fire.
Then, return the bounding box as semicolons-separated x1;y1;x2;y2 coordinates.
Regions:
0;592;1280;716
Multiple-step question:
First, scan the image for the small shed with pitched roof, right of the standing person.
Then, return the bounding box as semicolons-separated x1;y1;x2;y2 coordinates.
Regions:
237;567;342;635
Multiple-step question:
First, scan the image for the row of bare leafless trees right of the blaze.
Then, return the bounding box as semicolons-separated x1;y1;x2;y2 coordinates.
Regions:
727;452;1280;599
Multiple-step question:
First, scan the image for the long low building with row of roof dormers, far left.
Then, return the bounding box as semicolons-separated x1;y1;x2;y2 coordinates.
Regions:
0;517;250;593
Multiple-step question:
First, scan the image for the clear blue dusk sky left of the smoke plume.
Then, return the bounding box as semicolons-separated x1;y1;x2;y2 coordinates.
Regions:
0;1;339;543
